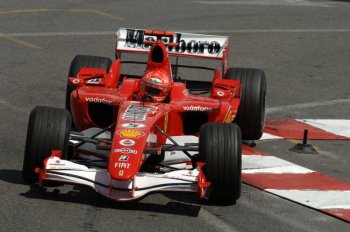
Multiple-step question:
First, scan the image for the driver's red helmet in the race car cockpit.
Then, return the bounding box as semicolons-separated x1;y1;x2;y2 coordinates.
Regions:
140;70;173;102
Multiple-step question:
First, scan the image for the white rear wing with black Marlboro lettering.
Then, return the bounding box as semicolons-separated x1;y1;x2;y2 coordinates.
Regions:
116;28;228;70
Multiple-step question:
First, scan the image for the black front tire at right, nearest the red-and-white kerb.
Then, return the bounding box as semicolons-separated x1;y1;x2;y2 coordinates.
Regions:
199;123;242;204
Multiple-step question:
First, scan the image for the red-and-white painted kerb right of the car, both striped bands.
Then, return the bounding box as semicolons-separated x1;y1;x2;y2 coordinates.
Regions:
242;119;350;222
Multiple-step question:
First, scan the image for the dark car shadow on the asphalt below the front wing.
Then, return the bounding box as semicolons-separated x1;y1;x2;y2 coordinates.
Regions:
0;169;201;217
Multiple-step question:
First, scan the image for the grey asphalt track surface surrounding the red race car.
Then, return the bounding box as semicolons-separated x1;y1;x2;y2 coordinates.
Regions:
0;0;350;231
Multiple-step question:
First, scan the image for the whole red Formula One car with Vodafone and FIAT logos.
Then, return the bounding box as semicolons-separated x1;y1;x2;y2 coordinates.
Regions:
23;28;266;203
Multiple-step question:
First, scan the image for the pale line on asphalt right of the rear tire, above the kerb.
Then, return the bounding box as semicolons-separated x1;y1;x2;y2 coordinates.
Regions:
266;99;350;114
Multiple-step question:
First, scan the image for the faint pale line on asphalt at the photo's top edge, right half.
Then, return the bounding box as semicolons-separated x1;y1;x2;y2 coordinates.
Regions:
193;0;331;7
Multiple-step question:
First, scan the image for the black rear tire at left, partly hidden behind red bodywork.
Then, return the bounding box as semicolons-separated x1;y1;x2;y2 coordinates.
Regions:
66;55;112;112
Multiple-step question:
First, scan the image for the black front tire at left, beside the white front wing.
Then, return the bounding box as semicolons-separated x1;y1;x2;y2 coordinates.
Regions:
22;106;72;183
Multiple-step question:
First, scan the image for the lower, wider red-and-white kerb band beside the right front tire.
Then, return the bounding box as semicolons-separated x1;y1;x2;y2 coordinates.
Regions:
242;146;350;222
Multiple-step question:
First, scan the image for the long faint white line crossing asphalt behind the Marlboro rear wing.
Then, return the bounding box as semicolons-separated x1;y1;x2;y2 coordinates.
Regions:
0;28;350;37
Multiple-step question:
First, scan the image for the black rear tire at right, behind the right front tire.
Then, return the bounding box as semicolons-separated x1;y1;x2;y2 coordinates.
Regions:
224;68;266;140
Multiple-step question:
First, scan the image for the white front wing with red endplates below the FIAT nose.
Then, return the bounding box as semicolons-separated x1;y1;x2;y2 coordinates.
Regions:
36;151;210;201
